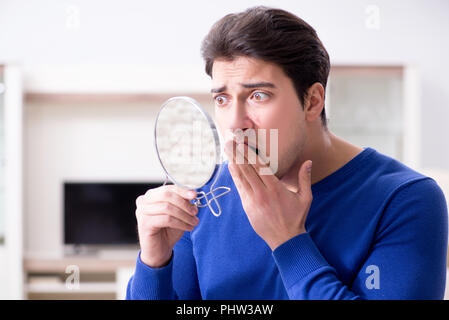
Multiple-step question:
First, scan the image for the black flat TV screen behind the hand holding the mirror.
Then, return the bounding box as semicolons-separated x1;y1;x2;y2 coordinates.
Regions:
64;182;162;245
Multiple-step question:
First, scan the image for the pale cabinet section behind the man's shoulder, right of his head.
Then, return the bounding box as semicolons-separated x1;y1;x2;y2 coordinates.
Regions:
326;66;421;168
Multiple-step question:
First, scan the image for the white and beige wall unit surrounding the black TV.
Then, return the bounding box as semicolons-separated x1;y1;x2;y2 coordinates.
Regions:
24;92;211;299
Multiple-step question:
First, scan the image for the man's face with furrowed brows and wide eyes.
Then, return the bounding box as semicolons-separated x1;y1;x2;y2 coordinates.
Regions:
211;57;306;178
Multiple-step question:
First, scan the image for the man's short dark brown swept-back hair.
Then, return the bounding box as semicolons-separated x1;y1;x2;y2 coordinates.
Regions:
201;6;330;127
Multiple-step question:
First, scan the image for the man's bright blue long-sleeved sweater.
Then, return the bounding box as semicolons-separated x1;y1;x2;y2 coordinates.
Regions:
127;148;447;299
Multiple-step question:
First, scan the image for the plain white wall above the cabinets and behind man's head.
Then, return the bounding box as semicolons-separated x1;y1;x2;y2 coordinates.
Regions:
0;0;449;169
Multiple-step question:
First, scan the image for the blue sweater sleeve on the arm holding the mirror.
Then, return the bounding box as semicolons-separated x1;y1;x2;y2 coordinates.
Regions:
126;232;201;300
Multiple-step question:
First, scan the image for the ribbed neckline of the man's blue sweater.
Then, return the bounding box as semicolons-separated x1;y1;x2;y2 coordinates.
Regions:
312;147;376;192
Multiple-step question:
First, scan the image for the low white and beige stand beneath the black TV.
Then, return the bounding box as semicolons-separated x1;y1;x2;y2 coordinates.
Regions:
24;251;138;300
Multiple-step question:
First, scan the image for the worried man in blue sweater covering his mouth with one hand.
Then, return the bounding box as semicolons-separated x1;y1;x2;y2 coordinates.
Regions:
127;7;447;299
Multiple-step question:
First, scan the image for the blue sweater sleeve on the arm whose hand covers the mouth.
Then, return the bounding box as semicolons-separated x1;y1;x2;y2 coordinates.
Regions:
273;178;448;300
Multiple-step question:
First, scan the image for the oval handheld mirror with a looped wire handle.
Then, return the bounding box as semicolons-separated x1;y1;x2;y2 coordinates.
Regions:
154;97;231;217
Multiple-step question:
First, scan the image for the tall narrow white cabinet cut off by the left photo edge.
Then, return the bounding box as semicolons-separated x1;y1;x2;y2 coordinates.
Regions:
0;65;23;299
